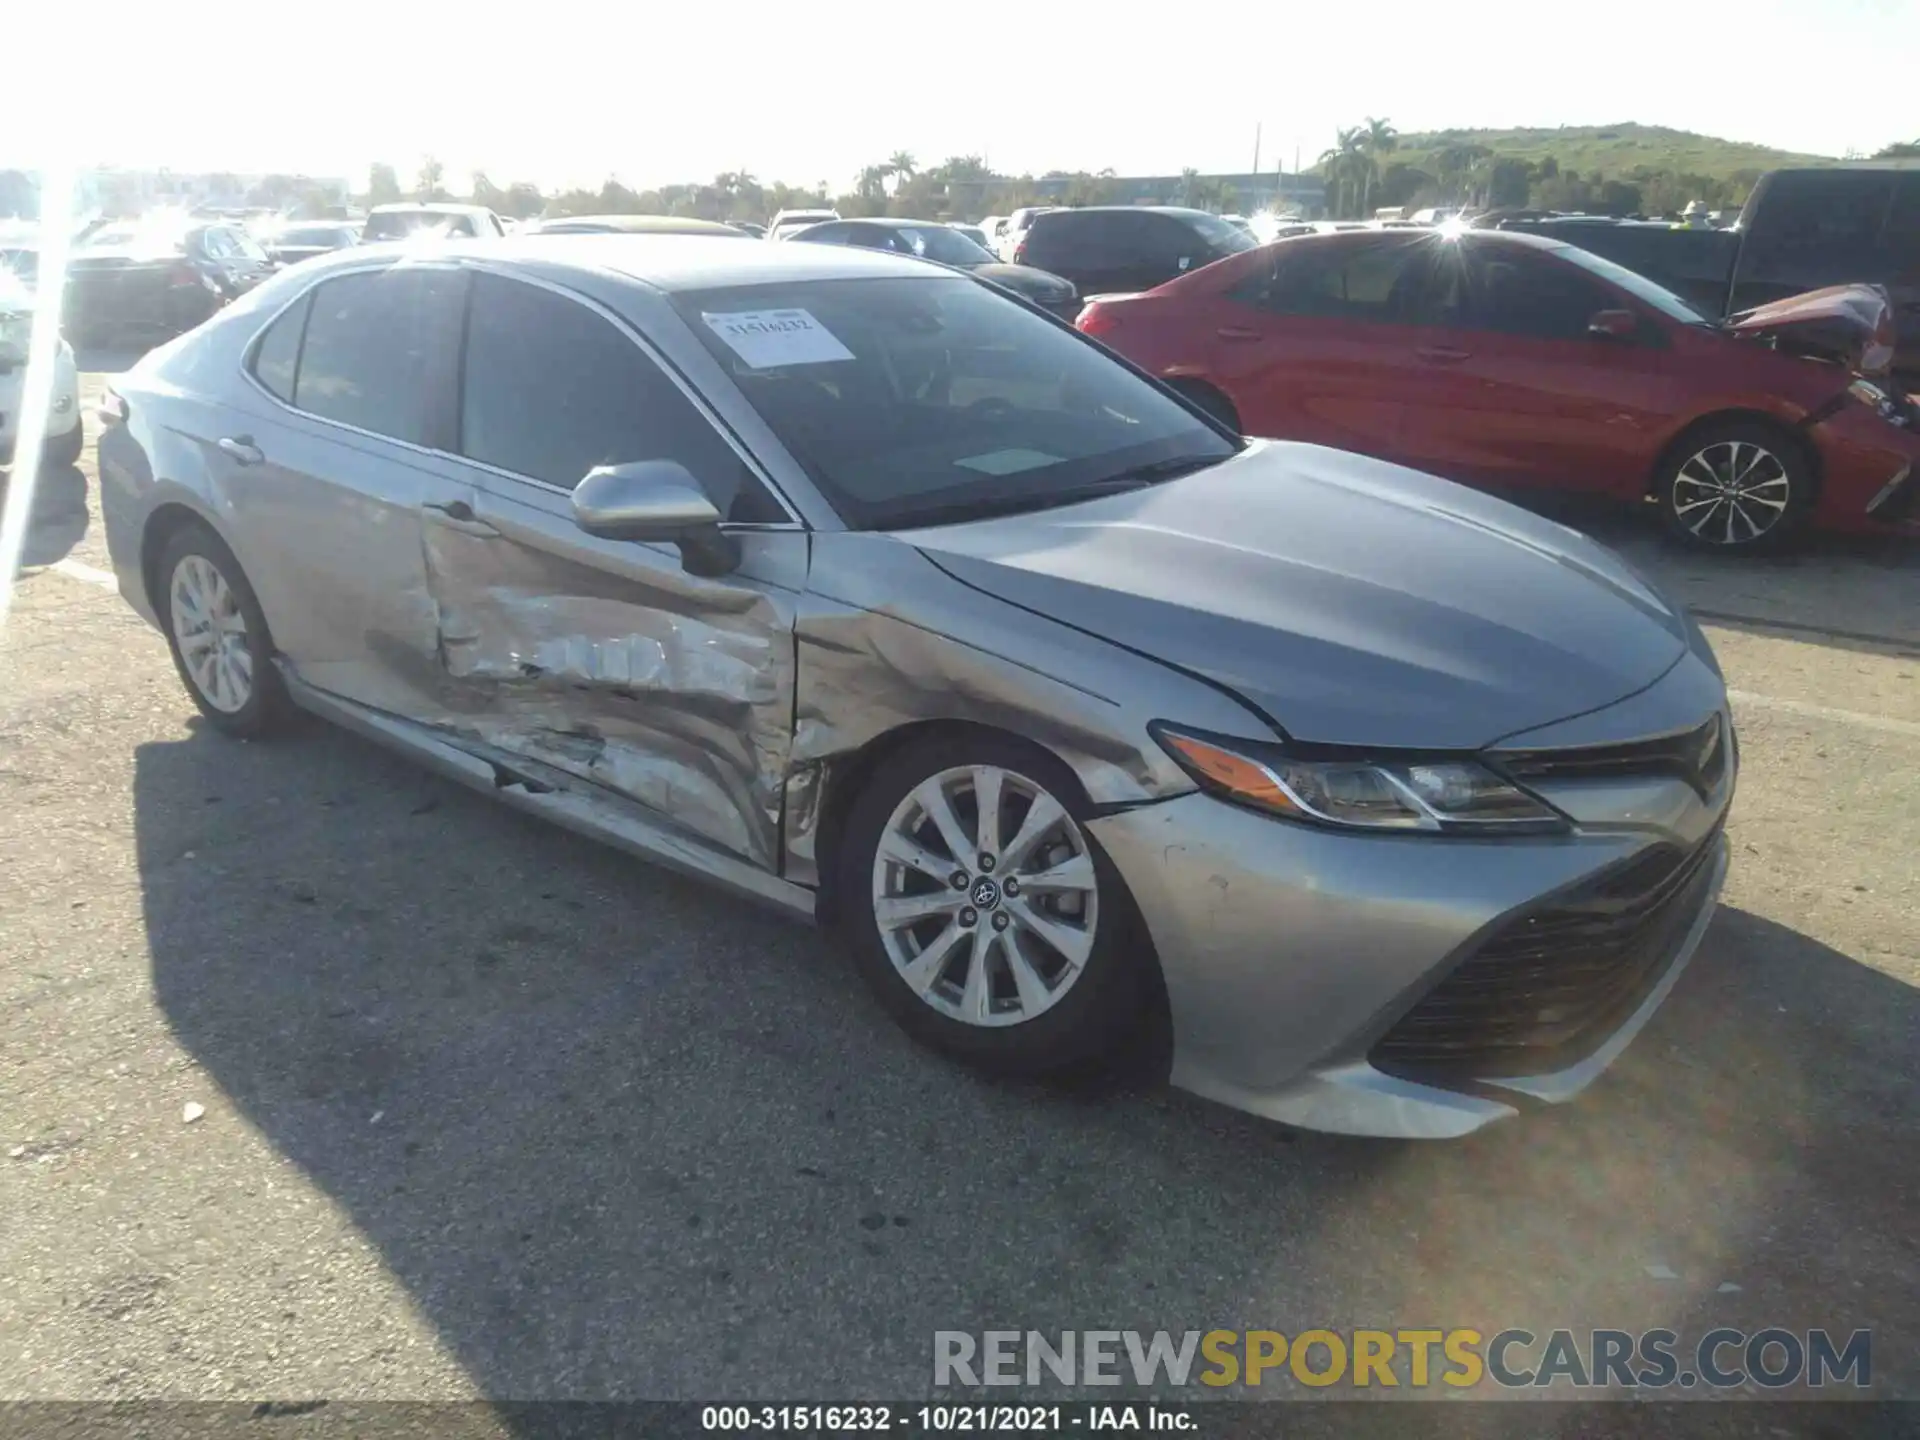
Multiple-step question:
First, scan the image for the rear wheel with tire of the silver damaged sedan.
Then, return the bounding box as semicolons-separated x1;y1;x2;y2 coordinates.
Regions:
156;520;294;739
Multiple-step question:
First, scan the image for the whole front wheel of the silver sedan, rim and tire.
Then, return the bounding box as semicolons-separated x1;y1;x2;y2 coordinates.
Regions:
837;733;1152;1075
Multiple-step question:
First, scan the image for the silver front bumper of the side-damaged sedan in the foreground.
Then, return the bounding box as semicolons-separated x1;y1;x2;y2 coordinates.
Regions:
1091;664;1736;1139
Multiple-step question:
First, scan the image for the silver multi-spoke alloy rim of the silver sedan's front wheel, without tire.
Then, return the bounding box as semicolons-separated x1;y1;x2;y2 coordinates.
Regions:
872;764;1100;1027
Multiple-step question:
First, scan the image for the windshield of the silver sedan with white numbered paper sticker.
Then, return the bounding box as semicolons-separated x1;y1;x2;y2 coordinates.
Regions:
674;275;1235;530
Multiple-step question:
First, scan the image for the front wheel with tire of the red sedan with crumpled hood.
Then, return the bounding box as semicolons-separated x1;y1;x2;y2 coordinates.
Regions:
1653;420;1814;555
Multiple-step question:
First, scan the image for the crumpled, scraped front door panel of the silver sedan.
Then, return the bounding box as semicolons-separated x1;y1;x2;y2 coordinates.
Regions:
420;480;806;870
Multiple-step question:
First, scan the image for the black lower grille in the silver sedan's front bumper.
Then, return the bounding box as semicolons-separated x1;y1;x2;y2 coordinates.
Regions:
1371;829;1720;1077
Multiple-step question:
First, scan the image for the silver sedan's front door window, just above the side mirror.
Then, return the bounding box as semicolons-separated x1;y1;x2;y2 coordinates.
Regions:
461;275;787;522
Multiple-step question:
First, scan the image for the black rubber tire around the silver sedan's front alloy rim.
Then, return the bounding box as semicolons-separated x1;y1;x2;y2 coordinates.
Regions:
835;730;1158;1077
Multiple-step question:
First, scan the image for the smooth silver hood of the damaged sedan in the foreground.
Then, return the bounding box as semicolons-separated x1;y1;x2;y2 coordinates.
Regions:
900;442;1688;751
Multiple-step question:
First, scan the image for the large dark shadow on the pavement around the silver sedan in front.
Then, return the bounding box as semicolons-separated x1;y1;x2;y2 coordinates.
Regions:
132;726;1920;1413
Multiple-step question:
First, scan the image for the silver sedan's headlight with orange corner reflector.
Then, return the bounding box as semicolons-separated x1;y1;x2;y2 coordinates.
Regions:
1152;726;1567;835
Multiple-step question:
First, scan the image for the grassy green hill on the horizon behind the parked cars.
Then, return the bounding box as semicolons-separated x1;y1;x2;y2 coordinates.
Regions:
1392;125;1834;180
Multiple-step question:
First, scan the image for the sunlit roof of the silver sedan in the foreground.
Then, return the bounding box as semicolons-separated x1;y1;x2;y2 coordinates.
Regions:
300;234;962;292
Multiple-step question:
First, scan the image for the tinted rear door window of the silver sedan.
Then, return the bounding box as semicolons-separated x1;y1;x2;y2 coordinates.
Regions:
294;265;463;445
